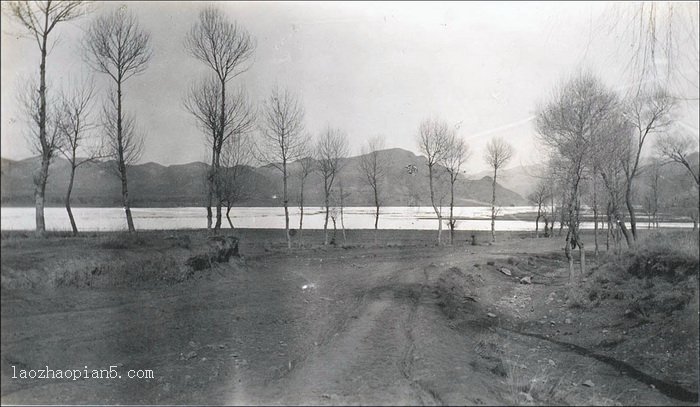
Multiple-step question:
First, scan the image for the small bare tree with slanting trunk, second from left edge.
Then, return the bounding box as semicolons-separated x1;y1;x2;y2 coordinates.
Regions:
59;82;105;235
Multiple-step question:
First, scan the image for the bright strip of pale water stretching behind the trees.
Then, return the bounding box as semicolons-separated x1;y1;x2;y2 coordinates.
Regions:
1;206;692;231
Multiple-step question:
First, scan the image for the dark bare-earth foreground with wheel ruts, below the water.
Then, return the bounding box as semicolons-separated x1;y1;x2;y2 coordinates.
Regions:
0;230;698;405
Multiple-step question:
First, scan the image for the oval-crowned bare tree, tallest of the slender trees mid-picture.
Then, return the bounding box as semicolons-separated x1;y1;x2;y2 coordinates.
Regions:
258;87;305;249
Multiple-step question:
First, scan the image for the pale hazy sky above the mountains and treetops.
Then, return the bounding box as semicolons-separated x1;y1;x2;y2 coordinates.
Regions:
1;2;698;172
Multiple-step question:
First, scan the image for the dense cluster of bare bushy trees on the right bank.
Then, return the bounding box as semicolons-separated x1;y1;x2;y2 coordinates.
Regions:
530;69;697;282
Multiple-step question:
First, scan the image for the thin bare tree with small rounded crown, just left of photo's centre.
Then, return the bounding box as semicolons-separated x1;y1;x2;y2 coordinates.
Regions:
315;126;349;245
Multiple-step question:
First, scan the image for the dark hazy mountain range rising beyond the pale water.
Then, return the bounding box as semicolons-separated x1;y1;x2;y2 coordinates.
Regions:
0;148;527;207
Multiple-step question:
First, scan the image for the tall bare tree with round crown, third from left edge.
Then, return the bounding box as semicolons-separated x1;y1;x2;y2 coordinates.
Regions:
83;8;152;232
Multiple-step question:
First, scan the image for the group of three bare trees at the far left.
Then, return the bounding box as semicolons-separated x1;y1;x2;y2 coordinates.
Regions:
6;1;152;233
